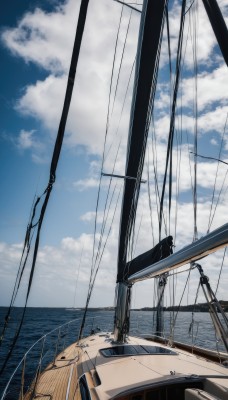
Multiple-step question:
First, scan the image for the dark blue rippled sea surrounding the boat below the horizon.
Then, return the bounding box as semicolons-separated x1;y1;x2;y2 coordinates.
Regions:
0;307;224;400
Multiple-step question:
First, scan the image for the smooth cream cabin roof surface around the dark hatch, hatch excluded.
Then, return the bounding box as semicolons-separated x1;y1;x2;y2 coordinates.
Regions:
77;334;228;400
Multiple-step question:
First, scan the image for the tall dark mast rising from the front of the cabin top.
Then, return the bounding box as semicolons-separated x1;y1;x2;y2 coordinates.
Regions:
114;0;167;342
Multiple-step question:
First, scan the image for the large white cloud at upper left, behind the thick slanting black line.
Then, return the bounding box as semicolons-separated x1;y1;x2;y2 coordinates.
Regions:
2;0;139;158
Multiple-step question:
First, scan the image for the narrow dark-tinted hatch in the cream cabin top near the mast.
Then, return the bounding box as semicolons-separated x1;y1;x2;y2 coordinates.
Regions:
100;345;177;357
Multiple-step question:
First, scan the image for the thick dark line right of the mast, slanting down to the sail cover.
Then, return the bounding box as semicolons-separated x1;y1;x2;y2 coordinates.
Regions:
159;0;186;240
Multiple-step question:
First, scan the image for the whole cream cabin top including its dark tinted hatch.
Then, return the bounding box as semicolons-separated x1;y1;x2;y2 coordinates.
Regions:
78;333;228;400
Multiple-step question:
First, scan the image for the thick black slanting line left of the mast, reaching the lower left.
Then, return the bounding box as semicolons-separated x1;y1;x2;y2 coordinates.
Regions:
0;0;89;374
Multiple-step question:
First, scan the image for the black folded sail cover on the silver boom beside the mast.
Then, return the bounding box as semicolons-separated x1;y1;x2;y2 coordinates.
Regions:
121;236;173;279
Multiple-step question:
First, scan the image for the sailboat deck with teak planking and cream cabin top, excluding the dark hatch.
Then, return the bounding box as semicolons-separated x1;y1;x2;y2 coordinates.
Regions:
29;334;228;400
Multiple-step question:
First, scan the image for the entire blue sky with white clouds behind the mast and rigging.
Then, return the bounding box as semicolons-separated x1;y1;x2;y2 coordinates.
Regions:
0;0;228;308
